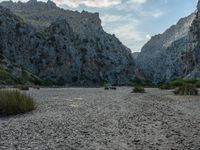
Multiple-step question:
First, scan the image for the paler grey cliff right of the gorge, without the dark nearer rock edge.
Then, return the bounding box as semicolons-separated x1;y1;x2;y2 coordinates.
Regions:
136;13;195;83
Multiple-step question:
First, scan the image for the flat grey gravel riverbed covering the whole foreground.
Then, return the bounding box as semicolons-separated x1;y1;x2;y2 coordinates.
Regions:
0;87;200;150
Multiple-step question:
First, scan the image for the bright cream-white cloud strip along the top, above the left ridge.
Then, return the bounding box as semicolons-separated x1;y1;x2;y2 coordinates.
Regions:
54;0;121;8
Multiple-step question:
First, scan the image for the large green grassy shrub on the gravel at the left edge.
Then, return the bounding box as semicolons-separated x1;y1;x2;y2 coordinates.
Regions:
0;90;36;115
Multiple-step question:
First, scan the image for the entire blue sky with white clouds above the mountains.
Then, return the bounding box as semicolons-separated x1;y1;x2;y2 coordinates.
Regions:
5;0;197;51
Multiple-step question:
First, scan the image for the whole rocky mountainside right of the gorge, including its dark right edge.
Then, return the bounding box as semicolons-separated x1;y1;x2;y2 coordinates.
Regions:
136;1;200;83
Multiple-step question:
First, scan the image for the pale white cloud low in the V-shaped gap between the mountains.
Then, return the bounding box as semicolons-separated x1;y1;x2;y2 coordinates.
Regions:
101;14;150;52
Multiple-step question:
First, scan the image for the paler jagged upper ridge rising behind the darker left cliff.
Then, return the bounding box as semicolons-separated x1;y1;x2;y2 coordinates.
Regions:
0;0;103;33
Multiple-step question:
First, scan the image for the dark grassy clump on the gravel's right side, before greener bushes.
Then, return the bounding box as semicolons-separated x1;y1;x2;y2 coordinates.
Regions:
174;84;198;95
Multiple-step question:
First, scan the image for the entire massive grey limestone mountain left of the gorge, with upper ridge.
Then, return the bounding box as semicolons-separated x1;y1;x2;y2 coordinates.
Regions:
0;0;134;86
